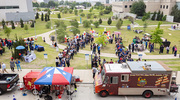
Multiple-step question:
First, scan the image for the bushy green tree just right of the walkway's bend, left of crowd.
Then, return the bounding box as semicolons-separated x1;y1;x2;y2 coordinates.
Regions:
56;27;68;43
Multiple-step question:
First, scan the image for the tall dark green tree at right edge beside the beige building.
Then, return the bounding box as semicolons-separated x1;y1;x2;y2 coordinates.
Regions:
171;5;180;22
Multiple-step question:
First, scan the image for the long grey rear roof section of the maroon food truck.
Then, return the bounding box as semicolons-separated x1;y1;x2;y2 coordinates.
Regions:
127;61;170;71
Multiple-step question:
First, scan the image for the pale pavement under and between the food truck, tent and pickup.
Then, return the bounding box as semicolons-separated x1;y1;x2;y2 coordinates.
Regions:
0;69;180;100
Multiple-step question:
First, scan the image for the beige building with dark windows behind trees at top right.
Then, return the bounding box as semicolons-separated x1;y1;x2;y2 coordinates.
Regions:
112;0;180;15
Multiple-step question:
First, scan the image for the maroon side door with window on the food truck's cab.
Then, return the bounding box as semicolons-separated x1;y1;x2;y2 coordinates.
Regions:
108;76;119;95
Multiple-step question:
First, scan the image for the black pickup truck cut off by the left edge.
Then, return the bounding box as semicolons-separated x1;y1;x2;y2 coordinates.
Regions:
0;73;19;95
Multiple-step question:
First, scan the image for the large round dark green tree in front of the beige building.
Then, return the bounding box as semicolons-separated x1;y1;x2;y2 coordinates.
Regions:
130;1;146;16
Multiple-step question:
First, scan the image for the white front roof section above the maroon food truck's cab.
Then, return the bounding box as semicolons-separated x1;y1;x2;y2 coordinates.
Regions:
104;63;131;73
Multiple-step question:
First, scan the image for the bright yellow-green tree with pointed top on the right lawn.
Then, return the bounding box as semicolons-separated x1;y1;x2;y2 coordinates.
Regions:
151;22;163;45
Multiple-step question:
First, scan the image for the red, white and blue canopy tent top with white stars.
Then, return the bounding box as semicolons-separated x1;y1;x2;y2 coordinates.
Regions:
34;67;73;85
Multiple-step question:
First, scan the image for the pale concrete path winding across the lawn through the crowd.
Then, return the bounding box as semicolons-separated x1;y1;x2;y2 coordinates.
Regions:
37;30;179;59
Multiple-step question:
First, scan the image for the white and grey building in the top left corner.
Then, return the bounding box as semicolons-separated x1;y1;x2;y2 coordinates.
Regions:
0;0;34;21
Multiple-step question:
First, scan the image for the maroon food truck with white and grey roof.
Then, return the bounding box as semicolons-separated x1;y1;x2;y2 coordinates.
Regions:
94;61;178;98
